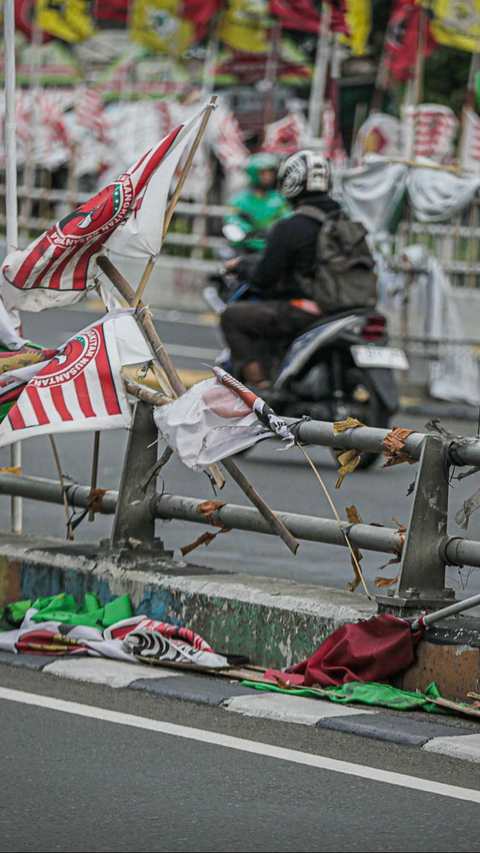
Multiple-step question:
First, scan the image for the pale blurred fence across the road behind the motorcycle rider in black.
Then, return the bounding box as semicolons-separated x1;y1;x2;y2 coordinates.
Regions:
5;185;480;394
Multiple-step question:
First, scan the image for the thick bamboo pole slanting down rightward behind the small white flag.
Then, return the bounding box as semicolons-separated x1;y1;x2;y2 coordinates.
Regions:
97;256;298;554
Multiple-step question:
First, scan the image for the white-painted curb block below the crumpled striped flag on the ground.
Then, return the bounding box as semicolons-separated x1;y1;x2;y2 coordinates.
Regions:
43;658;182;687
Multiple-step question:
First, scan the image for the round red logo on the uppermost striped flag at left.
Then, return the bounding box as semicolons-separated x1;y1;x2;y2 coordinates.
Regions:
49;175;133;247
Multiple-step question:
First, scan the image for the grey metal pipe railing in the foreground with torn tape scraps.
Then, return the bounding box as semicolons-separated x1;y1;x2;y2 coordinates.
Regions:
0;400;480;612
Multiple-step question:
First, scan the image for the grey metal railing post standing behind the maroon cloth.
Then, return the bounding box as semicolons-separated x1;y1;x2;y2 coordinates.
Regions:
376;435;455;610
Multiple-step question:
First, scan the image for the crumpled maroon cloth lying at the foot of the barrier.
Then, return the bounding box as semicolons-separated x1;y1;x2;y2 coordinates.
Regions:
265;613;422;687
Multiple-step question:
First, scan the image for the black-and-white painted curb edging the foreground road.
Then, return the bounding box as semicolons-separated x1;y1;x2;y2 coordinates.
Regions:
0;652;480;764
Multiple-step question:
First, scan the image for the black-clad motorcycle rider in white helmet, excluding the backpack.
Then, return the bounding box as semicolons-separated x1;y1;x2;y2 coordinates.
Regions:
220;150;339;390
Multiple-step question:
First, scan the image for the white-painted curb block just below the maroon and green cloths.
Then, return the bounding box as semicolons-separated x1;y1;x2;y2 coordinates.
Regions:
224;691;376;726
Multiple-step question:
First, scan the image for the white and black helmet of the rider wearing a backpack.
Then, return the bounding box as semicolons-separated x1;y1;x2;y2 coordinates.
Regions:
278;149;332;199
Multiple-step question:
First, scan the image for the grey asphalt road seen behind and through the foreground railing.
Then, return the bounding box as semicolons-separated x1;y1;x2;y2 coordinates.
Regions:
0;310;480;596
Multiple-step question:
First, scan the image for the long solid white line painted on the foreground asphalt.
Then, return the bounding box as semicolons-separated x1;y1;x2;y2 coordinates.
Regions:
0;687;480;803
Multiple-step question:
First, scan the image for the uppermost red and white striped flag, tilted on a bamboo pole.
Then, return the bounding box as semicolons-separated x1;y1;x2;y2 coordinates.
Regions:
2;103;208;311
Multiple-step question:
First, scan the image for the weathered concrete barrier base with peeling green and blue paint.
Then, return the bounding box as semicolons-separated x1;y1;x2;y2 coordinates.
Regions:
0;535;376;668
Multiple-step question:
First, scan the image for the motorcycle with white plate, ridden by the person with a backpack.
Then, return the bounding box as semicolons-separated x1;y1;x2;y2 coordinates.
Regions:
204;270;408;468
